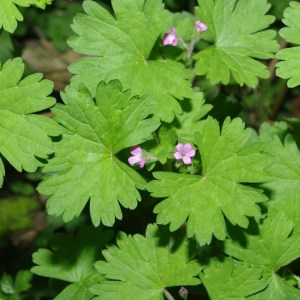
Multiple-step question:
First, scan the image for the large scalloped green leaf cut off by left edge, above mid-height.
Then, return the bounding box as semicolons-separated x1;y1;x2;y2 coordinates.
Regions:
0;58;61;185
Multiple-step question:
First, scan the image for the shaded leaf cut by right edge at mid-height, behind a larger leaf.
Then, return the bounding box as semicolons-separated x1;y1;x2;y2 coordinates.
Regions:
262;135;300;233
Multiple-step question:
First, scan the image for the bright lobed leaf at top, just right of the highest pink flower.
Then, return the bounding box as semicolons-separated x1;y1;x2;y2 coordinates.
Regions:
194;0;278;87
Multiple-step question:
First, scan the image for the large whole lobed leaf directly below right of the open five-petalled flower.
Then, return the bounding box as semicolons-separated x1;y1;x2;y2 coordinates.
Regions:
147;118;271;245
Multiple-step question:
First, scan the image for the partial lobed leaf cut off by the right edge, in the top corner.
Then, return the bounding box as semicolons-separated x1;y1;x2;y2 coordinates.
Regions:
276;1;300;88
